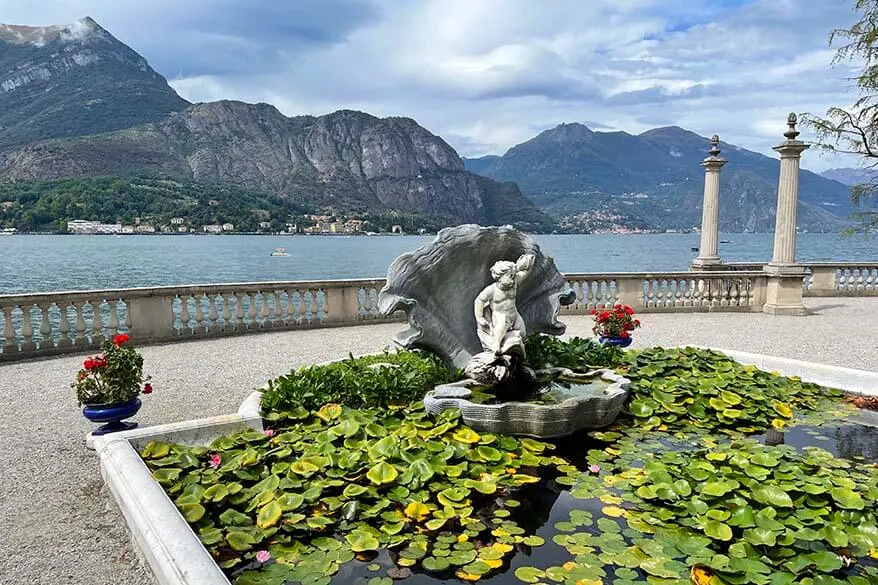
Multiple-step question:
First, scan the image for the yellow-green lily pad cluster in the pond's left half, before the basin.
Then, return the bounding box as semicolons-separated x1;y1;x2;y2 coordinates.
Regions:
142;404;565;585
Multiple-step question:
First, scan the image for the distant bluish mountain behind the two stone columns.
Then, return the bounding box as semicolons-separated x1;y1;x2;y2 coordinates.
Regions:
465;123;851;232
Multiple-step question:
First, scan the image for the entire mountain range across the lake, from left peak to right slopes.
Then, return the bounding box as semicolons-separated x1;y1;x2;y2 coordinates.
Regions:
0;18;850;232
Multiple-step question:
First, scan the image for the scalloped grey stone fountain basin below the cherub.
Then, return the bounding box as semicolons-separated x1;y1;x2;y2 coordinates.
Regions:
424;368;630;439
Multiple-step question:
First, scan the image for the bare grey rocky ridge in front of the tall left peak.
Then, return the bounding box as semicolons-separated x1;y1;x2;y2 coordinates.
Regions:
0;101;552;229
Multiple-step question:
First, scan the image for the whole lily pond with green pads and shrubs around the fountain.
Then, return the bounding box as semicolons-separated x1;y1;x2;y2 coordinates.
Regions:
141;336;878;585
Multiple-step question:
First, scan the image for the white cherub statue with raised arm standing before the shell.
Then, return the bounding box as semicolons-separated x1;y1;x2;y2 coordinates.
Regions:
466;254;535;383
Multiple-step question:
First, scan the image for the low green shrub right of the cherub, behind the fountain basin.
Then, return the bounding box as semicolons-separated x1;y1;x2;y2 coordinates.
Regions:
524;334;625;370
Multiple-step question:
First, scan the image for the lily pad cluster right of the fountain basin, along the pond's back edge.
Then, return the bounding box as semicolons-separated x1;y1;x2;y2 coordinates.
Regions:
619;347;840;433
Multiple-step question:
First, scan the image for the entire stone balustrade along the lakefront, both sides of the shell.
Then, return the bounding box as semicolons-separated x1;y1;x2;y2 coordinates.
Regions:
0;263;878;361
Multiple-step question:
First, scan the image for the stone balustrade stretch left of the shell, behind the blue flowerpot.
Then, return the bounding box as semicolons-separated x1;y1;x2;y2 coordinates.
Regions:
0;279;392;361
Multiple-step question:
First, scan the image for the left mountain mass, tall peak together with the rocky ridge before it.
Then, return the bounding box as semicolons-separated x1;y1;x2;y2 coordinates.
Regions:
0;18;555;231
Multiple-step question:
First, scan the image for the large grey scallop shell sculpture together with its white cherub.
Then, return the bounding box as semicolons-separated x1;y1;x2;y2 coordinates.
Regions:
378;224;576;368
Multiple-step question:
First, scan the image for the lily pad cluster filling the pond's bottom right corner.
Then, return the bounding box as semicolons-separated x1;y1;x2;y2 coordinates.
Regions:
552;432;878;585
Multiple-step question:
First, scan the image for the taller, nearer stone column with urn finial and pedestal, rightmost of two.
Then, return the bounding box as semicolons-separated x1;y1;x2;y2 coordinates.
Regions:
763;114;809;315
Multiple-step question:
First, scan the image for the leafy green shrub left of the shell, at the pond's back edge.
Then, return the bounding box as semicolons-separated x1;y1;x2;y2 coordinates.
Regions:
262;351;459;414
